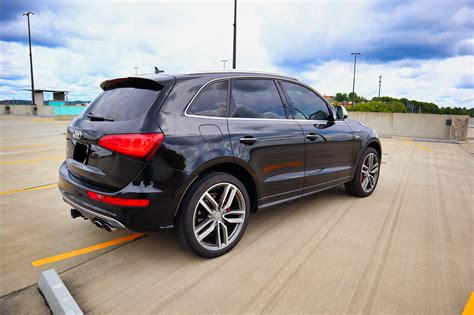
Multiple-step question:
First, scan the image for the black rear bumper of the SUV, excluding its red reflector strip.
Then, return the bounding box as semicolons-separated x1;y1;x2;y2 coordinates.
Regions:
58;162;190;232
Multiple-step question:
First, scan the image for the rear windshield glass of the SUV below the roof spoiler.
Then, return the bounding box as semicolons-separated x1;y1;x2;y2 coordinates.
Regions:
83;87;160;121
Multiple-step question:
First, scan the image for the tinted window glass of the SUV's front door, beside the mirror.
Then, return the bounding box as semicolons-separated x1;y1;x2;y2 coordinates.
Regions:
282;82;330;120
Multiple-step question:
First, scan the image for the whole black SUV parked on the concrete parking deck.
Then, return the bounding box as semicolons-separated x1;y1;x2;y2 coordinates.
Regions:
59;71;381;257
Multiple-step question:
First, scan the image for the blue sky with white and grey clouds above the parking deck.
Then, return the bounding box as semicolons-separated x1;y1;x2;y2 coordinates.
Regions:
0;0;474;108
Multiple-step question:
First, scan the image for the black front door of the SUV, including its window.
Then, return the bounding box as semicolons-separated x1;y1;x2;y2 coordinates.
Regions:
280;81;354;194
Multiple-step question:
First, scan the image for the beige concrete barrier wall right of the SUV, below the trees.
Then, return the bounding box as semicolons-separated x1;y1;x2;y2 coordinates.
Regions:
349;112;469;141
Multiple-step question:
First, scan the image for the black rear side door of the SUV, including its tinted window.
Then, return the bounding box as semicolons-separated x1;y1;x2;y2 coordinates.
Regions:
227;78;305;208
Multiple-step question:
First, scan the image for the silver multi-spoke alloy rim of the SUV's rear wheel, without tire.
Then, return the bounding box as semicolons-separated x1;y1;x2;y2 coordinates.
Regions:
193;183;246;251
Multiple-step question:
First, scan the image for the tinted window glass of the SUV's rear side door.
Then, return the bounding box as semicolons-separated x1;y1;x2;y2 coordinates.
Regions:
230;79;286;119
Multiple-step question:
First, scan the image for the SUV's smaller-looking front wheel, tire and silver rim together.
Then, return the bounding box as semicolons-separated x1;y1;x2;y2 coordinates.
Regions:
344;148;380;197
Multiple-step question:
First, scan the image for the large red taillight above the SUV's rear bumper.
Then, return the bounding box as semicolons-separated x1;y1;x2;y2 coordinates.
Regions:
99;133;165;160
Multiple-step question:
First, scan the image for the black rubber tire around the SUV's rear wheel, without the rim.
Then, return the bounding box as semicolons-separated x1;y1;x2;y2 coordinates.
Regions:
178;172;250;258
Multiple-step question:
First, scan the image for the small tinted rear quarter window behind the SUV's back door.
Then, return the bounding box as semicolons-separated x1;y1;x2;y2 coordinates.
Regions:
188;81;227;117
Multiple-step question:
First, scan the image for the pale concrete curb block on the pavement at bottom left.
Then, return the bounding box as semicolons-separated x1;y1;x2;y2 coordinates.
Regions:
38;269;83;315
